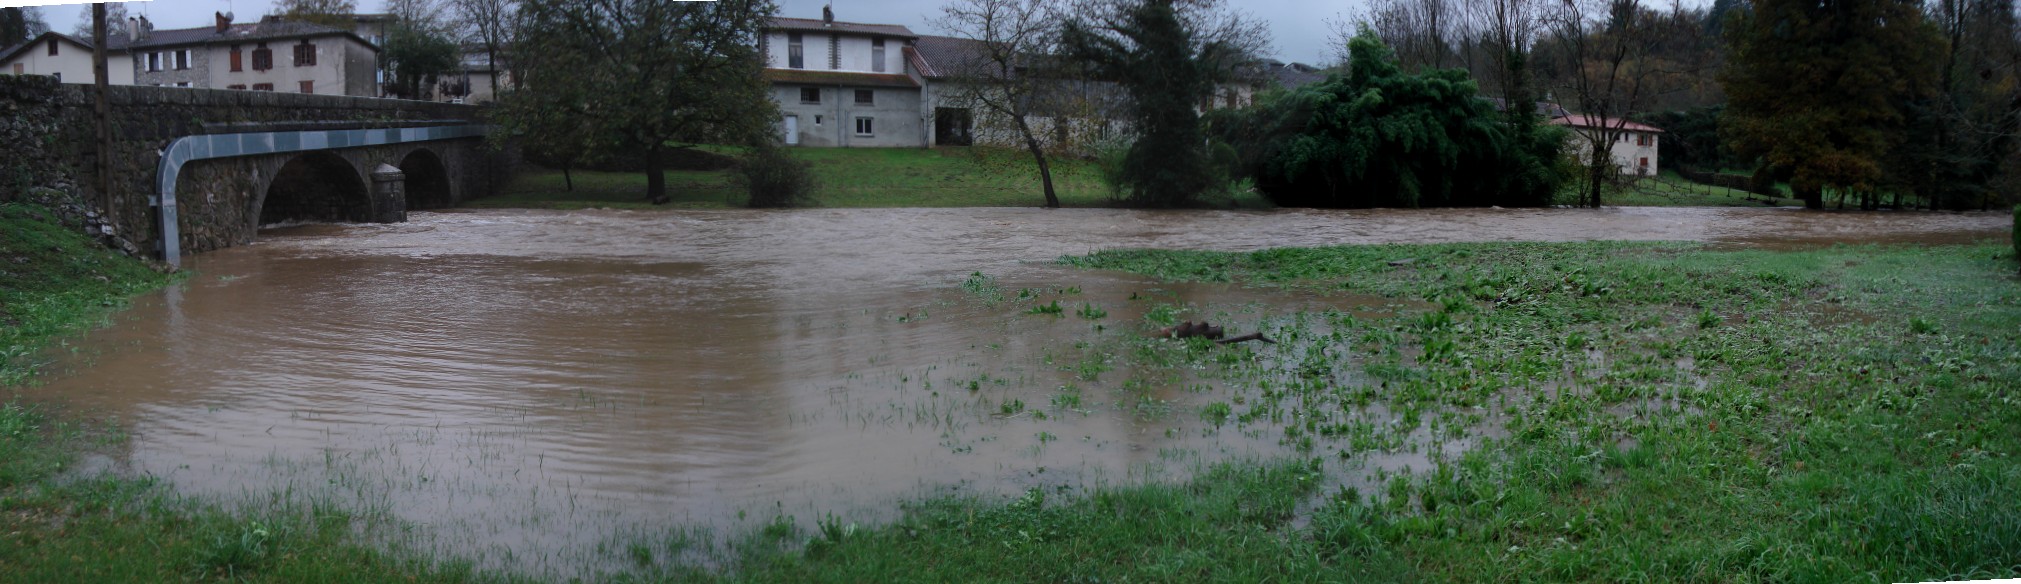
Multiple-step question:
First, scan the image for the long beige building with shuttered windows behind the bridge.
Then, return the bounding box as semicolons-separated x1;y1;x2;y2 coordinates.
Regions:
109;14;378;97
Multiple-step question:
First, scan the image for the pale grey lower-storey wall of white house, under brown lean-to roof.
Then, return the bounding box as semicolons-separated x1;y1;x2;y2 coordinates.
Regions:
772;83;928;148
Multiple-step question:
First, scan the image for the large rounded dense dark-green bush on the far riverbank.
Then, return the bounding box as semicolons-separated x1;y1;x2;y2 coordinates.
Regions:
1220;30;1564;206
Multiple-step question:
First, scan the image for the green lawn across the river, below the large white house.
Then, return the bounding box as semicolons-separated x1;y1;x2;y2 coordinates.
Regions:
465;148;1269;208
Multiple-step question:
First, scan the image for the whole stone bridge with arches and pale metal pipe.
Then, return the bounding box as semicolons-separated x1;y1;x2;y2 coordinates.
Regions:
0;75;515;263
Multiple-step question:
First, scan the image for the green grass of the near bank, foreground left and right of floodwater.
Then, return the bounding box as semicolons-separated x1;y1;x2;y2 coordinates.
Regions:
0;197;2021;582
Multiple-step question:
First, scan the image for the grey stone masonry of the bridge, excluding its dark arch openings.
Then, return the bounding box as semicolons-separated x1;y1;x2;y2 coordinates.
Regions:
0;75;515;251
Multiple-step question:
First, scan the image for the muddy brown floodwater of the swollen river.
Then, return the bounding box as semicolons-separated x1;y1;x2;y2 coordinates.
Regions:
28;208;2009;570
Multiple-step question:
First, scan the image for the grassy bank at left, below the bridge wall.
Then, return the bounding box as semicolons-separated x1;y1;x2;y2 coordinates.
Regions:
0;204;505;582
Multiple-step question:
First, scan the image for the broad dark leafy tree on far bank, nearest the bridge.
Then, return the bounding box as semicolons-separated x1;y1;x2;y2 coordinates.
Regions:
501;0;780;202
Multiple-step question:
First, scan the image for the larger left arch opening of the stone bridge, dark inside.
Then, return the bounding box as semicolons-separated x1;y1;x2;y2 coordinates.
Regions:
259;152;372;226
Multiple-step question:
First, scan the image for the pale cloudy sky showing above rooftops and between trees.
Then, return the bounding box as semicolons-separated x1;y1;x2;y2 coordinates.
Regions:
27;0;1362;65
